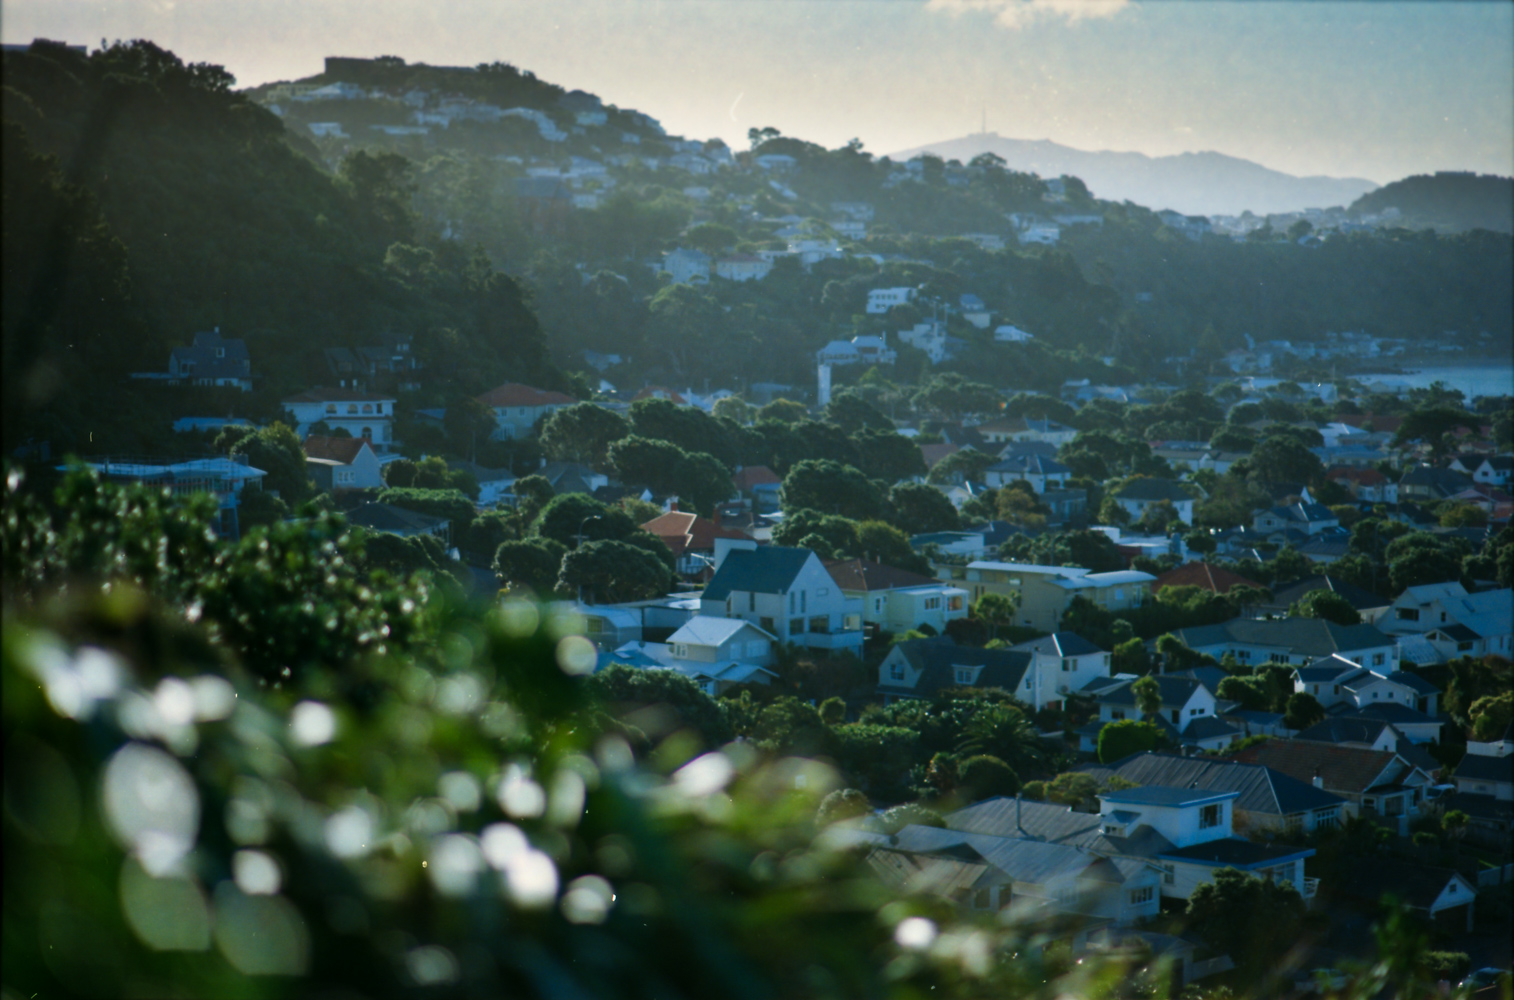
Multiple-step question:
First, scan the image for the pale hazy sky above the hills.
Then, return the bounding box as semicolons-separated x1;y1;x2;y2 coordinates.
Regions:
0;0;1514;183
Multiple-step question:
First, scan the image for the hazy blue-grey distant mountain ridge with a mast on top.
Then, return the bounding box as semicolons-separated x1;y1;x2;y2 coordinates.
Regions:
892;132;1378;215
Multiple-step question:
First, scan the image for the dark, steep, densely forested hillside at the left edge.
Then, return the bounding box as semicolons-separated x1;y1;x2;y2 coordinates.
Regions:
0;42;562;449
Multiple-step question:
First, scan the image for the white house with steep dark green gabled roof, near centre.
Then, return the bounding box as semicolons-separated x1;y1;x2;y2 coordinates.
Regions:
699;539;863;657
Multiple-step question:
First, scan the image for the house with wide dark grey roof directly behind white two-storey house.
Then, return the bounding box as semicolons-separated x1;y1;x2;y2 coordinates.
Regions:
1077;750;1346;837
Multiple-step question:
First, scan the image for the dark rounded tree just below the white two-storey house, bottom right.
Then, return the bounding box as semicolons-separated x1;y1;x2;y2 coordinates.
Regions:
1188;868;1305;979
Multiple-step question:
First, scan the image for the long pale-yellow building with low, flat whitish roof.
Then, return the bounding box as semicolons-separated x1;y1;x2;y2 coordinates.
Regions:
936;561;1157;632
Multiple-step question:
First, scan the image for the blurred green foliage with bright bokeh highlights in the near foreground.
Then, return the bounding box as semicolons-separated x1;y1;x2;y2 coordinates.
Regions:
0;474;1465;1000
